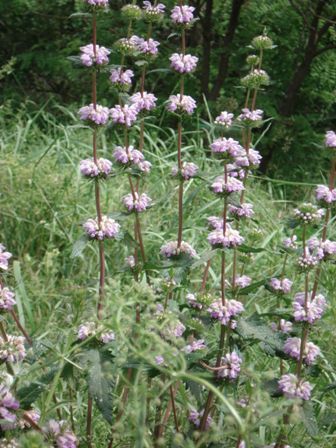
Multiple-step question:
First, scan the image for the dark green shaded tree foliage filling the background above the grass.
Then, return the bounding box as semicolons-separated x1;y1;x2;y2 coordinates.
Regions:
0;0;336;176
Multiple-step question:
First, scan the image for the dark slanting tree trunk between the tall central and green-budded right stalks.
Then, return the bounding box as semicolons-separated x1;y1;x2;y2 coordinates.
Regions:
209;0;245;100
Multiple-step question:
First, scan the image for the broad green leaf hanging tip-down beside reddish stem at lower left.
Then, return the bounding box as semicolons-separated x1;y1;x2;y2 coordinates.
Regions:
87;350;114;425
